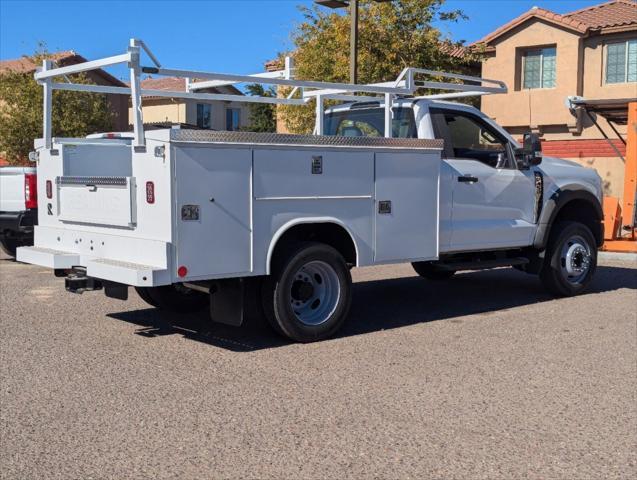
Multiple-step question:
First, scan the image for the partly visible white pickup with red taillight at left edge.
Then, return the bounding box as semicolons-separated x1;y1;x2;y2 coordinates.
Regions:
0;167;38;257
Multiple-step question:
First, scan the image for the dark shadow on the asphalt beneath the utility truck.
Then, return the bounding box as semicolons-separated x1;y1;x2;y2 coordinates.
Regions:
108;266;637;352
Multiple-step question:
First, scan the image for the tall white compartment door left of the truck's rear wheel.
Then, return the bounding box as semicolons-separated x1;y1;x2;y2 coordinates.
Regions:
175;146;252;279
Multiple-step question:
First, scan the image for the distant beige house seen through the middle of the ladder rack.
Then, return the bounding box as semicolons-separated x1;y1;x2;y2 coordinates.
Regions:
129;77;250;130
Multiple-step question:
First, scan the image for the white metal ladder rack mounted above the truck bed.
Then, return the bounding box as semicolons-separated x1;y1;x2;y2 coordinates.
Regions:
34;38;507;151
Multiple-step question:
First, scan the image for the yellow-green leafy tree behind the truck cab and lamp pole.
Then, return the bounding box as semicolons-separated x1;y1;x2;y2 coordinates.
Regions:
280;0;468;133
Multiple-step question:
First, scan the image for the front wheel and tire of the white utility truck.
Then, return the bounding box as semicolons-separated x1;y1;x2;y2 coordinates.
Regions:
540;222;597;297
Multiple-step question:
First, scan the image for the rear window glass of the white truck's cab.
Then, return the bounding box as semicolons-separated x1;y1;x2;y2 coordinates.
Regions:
324;107;418;138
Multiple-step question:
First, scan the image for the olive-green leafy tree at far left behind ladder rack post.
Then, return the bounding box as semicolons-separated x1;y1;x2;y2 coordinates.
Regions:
0;52;113;164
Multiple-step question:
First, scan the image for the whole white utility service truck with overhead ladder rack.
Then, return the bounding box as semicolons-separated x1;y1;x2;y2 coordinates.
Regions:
18;40;603;342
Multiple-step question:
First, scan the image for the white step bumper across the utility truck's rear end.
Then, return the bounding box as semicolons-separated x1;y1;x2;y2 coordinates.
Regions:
16;247;170;287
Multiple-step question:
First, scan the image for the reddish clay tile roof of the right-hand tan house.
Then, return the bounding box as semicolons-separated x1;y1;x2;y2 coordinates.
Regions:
472;0;637;45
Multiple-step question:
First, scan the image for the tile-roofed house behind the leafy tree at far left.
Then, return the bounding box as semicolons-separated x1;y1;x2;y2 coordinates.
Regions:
0;50;128;130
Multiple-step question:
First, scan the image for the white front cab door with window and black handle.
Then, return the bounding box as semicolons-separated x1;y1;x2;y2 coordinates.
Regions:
430;108;535;251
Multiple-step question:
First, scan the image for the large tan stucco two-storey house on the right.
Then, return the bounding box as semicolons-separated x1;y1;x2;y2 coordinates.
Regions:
473;0;637;197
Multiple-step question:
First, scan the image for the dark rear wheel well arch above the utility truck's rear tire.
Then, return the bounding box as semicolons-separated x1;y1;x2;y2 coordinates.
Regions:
270;222;356;265
